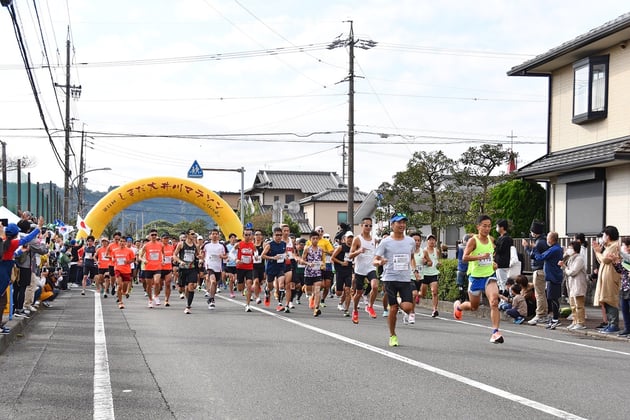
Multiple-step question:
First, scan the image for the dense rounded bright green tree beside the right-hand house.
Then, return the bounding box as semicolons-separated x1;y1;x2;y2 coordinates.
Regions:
488;179;546;237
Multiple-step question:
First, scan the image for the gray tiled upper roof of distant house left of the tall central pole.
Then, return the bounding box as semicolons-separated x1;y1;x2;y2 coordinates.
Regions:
253;171;344;195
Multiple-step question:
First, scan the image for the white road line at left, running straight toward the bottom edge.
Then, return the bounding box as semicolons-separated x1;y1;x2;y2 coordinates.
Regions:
93;293;114;420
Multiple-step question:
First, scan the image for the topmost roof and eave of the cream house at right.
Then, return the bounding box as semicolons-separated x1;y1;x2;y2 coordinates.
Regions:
507;12;630;76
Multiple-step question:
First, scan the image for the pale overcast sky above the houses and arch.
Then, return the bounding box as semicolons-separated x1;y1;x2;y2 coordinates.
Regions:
0;0;628;198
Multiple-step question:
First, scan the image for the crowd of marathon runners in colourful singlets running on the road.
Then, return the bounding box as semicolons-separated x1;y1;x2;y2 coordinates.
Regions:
3;213;503;346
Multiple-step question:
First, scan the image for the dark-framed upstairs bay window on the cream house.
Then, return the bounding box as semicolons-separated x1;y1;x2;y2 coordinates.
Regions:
573;55;608;124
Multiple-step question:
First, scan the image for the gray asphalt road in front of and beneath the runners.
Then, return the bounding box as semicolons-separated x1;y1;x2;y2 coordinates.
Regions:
0;289;630;419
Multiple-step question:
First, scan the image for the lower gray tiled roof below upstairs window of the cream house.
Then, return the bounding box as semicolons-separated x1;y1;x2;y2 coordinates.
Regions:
516;136;630;179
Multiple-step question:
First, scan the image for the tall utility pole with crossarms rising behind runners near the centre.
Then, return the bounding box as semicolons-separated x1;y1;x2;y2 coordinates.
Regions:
327;20;377;228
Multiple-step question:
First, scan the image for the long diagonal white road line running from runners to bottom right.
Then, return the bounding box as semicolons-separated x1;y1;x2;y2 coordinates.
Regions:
219;296;584;420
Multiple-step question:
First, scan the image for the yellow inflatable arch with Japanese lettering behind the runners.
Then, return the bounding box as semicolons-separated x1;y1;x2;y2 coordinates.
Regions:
77;177;243;239
